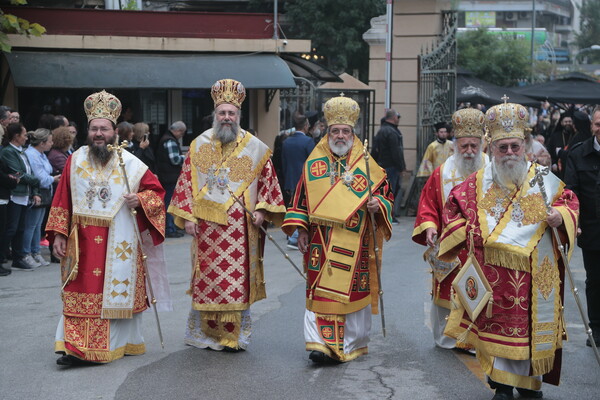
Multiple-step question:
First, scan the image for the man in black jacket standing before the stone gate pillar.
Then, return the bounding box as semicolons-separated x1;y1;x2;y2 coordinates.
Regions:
373;109;406;223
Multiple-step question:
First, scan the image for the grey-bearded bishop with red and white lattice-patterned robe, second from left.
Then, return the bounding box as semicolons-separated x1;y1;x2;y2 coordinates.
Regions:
168;79;285;351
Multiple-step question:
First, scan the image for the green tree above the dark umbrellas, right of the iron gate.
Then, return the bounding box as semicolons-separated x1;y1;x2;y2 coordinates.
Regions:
457;28;531;87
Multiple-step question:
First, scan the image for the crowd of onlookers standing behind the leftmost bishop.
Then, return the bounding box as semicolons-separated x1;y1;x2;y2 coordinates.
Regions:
0;101;187;276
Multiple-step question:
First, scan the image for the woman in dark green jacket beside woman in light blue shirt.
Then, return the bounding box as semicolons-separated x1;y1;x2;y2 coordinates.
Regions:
0;123;41;271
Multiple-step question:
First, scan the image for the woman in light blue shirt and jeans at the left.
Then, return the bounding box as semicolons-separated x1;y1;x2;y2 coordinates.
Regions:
22;128;60;267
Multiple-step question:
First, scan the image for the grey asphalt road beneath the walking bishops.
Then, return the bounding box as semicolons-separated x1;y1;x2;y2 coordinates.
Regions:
0;218;600;400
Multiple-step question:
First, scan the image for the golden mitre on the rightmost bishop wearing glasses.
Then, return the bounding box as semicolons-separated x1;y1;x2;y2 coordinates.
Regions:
485;101;529;142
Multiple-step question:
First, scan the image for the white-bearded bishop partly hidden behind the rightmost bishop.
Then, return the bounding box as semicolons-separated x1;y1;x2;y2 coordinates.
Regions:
412;108;488;349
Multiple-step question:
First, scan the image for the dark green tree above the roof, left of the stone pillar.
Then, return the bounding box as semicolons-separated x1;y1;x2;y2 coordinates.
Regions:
283;0;385;80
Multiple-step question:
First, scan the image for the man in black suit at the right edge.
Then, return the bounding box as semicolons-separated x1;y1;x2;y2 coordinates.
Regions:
565;106;600;346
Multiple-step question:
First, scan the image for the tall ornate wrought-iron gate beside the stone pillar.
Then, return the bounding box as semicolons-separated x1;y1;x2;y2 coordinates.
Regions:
403;11;457;215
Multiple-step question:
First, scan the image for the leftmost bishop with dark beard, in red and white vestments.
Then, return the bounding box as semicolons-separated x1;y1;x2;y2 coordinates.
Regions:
46;91;165;365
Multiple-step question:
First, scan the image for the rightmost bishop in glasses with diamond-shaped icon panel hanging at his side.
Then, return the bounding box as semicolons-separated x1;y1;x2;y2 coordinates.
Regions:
438;102;579;399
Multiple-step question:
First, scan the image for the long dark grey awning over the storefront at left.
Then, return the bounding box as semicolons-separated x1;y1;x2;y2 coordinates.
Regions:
5;51;296;89
